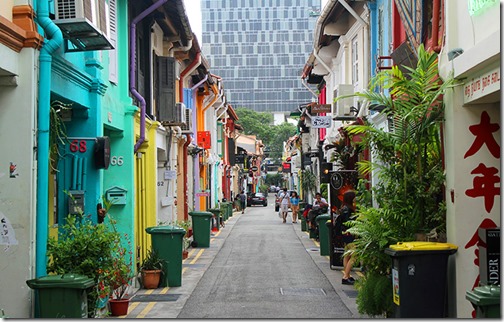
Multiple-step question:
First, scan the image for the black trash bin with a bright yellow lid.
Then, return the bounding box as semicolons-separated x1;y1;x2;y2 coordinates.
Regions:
385;242;458;318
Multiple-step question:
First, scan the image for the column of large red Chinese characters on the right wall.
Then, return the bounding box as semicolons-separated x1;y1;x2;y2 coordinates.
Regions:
460;110;501;317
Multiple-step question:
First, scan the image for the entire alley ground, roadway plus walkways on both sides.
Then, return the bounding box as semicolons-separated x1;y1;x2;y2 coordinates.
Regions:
122;195;362;319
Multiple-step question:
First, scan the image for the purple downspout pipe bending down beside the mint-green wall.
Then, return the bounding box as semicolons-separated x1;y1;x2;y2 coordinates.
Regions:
129;0;168;153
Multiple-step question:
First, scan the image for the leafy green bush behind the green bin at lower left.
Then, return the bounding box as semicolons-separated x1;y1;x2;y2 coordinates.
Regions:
47;213;133;317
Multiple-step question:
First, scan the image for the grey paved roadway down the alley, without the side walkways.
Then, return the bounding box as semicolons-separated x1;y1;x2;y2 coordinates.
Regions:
178;195;358;319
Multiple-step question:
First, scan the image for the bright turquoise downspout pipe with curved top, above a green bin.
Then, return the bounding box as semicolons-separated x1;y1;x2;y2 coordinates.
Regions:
35;0;63;277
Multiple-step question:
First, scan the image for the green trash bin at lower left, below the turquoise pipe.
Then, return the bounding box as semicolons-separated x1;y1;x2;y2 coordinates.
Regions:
26;274;95;319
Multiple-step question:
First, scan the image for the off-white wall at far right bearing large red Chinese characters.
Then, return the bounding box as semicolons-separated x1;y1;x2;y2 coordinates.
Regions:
439;0;502;318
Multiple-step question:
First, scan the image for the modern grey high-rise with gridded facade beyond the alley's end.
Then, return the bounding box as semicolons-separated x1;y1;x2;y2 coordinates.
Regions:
200;0;320;113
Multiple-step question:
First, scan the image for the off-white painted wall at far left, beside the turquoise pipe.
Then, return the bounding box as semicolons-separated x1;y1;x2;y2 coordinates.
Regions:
0;41;38;318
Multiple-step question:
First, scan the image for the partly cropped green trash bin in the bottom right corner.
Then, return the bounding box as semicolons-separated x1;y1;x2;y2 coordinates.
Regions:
466;285;501;319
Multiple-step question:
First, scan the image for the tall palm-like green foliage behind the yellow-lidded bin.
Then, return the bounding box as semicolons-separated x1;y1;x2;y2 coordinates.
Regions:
338;46;452;316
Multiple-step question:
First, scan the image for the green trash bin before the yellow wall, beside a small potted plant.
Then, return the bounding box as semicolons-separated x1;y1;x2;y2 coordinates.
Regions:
145;226;186;287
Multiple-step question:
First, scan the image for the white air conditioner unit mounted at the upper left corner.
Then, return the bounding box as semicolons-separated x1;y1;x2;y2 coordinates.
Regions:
54;0;115;52
